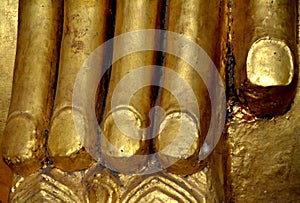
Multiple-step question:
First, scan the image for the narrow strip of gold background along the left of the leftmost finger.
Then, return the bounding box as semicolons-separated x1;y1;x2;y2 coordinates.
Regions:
0;0;18;202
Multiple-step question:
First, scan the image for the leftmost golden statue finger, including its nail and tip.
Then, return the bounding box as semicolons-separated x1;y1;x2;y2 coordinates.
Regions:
2;1;61;174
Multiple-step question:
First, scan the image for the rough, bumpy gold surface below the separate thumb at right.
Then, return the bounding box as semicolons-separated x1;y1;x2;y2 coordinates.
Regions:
228;107;300;202
